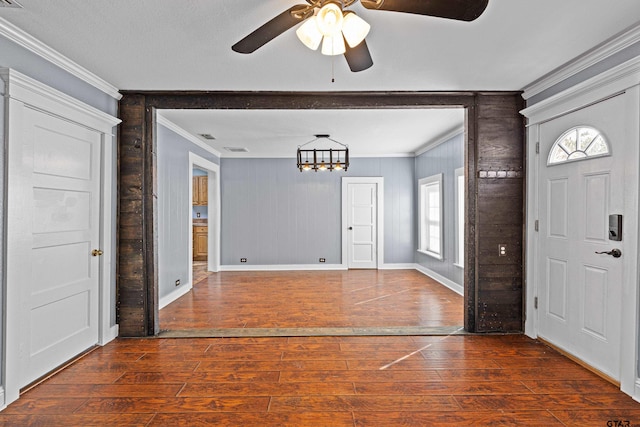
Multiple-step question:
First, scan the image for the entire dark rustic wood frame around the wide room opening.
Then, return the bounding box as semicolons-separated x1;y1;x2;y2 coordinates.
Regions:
118;91;524;336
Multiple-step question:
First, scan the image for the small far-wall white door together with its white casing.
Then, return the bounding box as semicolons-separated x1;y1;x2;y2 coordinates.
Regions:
342;177;384;268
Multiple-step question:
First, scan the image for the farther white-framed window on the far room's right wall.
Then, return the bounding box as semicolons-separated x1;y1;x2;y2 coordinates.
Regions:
418;174;443;259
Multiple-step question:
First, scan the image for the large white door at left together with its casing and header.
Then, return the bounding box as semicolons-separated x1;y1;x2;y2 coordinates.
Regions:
0;69;119;406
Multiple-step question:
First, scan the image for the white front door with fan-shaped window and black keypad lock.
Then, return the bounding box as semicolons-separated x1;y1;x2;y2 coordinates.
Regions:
538;96;624;380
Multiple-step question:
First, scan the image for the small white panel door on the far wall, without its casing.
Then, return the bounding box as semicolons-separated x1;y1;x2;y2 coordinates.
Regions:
347;183;378;268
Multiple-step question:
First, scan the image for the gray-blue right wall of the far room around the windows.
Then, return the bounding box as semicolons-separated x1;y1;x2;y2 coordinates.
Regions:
413;134;464;285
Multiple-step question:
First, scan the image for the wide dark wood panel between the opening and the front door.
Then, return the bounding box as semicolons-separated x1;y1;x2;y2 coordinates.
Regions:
474;94;525;332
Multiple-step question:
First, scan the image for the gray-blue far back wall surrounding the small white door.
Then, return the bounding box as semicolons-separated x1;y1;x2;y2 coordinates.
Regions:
220;157;415;265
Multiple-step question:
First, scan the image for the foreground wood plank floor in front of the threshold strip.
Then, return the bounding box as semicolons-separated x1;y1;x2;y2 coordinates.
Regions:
5;335;640;427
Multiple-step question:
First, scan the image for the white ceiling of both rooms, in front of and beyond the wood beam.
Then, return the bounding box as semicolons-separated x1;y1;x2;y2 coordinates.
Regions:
0;0;640;157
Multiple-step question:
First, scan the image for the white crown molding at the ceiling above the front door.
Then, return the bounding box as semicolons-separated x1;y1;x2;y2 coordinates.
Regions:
522;24;640;99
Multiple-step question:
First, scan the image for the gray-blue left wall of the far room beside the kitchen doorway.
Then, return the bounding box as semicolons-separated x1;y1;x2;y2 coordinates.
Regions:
156;125;219;298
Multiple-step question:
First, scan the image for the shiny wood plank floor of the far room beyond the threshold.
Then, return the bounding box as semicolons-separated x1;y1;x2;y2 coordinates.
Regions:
160;270;464;330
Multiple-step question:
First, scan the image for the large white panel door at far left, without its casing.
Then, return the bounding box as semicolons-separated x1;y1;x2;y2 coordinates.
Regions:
16;108;101;385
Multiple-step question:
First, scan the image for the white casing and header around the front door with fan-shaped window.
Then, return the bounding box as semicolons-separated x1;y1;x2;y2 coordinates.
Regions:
522;58;640;401
